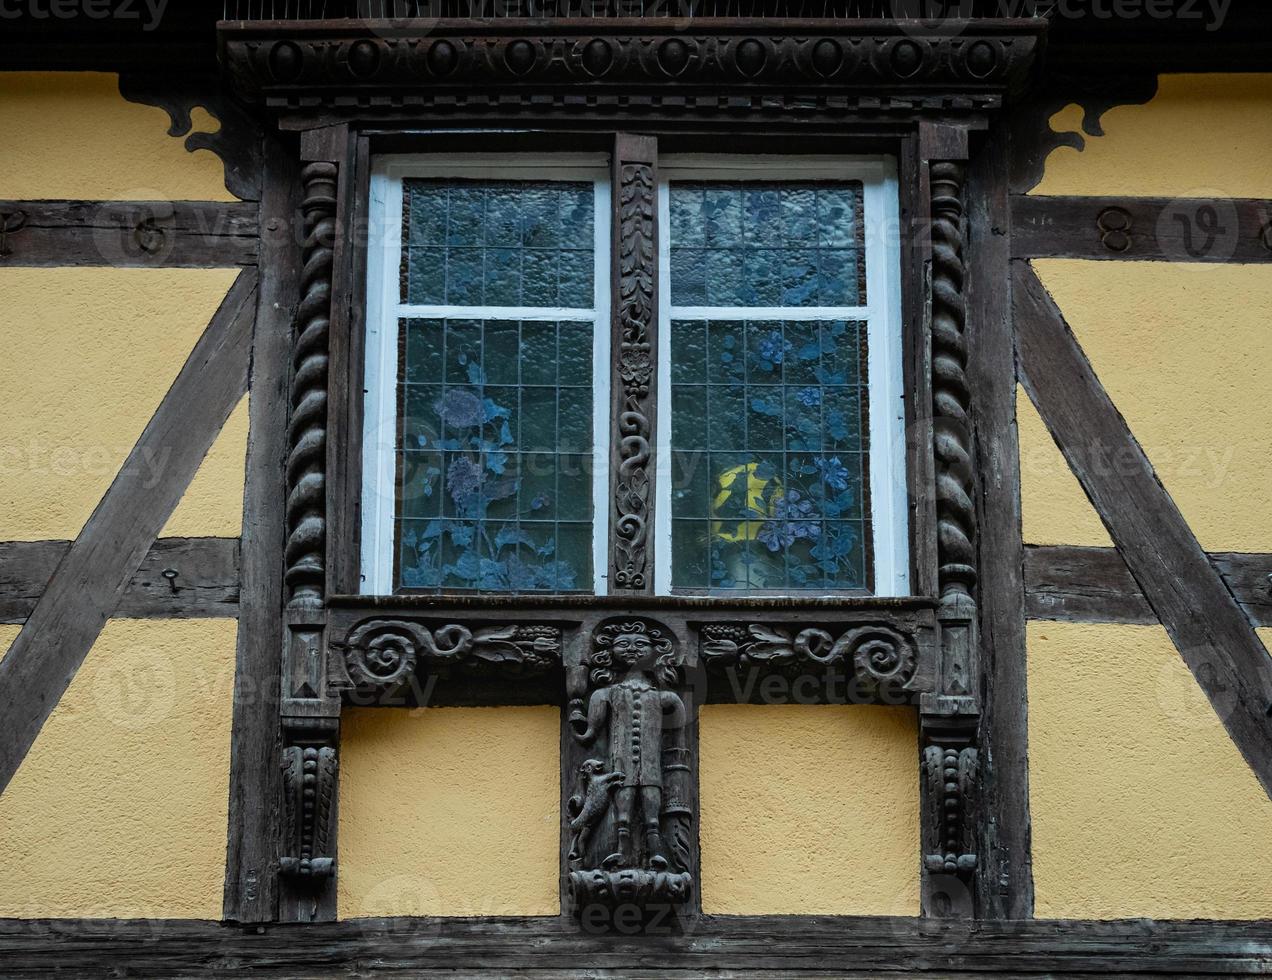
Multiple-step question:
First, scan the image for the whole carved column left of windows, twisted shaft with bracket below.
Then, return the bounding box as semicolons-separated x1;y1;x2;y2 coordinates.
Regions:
279;148;340;921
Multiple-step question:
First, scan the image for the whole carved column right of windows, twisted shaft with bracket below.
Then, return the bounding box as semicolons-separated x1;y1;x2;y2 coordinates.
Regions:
920;126;981;918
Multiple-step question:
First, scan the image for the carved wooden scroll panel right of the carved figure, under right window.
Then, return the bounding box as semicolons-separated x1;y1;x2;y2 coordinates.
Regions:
698;622;920;704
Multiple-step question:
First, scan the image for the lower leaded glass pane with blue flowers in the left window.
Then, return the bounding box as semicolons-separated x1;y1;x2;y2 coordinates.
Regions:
397;319;593;592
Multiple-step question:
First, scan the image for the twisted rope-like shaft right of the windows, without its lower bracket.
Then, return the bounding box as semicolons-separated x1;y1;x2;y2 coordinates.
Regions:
931;162;977;602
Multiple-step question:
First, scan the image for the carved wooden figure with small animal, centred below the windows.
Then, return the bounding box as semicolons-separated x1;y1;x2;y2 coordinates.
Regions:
565;619;697;924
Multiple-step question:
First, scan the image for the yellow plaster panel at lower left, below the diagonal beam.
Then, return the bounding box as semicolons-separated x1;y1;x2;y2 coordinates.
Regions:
0;620;237;919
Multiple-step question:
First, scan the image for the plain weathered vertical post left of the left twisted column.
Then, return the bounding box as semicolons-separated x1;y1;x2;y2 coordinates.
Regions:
223;140;300;923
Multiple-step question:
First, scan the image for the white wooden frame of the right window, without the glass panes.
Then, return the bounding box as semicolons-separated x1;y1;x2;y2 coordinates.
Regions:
654;154;909;597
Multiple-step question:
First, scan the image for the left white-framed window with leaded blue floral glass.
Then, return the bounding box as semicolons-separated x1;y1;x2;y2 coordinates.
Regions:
363;157;609;593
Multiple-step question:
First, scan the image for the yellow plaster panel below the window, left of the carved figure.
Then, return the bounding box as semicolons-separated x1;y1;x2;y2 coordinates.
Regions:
340;708;561;918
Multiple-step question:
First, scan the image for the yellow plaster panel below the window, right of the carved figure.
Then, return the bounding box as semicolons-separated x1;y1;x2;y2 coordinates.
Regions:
700;705;920;915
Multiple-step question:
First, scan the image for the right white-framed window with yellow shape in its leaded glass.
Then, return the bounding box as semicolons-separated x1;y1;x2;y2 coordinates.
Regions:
656;158;908;594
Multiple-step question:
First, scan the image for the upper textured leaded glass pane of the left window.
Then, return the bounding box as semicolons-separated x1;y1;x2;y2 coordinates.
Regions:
401;179;595;309
